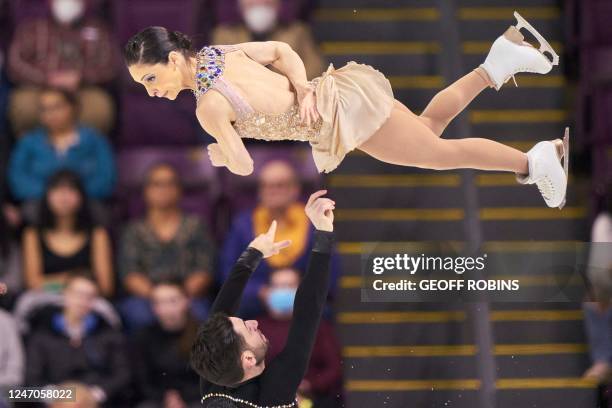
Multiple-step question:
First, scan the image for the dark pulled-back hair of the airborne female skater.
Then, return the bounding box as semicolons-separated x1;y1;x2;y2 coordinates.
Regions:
123;26;193;66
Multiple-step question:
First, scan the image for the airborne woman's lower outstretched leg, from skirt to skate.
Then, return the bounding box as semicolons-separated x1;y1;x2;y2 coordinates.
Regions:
359;104;529;174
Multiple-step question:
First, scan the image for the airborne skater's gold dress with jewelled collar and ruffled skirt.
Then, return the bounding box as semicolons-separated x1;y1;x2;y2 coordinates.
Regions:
195;45;394;173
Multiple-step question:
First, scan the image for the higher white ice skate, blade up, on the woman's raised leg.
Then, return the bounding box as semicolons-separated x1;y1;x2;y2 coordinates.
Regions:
480;11;559;91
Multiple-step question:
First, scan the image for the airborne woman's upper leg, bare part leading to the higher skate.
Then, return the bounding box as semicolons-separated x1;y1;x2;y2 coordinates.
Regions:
419;67;491;136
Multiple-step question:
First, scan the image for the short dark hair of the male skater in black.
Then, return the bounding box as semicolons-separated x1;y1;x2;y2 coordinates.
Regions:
191;313;244;387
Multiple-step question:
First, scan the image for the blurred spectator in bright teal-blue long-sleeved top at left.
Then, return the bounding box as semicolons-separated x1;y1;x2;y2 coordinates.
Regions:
8;88;116;214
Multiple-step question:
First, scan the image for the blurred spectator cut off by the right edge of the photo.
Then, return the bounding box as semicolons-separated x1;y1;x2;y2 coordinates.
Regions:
584;190;612;383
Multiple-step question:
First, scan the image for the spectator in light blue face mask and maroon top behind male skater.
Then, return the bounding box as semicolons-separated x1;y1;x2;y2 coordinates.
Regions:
257;268;342;408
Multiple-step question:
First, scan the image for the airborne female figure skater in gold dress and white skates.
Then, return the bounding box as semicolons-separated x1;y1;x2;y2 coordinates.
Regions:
124;12;569;208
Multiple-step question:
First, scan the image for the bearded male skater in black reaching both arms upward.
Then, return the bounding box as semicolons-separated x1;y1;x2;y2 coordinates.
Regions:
191;190;335;408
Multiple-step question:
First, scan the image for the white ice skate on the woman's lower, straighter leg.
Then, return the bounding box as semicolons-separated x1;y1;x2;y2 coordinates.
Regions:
516;128;569;209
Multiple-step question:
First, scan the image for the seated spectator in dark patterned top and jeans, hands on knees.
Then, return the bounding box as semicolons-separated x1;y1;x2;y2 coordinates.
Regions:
119;164;214;329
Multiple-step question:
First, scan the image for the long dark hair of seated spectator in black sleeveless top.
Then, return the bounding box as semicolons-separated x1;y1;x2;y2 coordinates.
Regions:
39;169;94;231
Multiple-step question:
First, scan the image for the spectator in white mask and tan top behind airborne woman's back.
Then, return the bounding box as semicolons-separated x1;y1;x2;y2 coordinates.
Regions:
211;0;323;79
